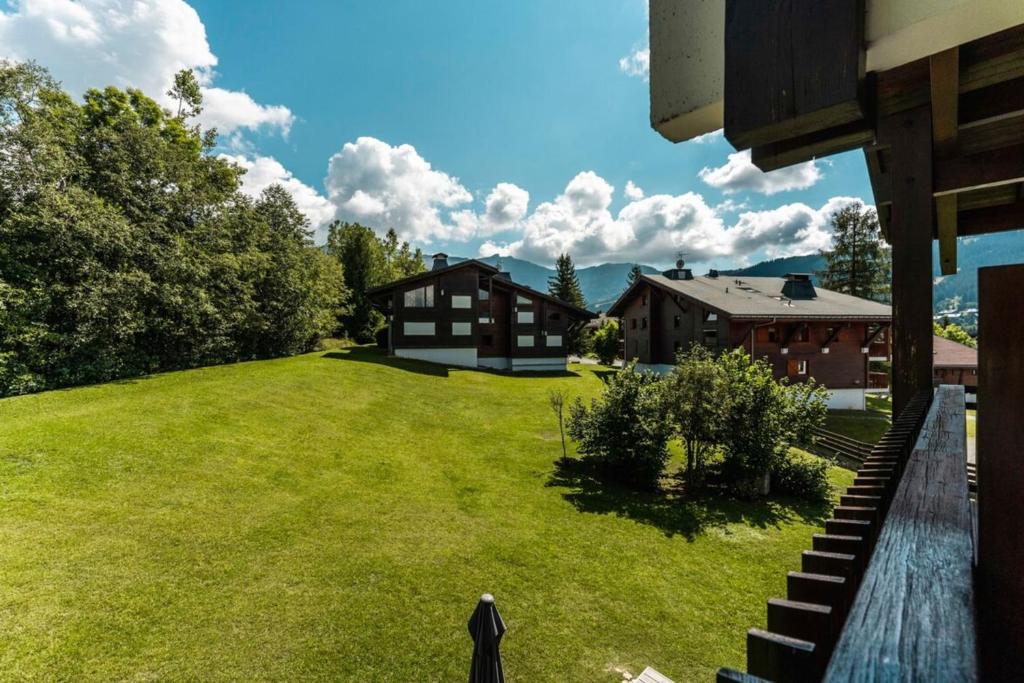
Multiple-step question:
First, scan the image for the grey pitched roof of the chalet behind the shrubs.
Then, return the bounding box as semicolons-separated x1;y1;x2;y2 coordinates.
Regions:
608;275;892;321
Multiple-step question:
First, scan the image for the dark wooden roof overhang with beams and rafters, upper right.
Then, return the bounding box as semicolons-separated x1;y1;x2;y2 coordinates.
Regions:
723;0;1024;273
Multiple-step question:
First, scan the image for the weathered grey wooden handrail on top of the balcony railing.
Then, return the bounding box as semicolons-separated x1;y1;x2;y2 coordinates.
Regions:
824;385;978;682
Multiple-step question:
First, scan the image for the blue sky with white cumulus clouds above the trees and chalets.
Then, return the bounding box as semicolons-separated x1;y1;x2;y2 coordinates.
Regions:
0;0;871;266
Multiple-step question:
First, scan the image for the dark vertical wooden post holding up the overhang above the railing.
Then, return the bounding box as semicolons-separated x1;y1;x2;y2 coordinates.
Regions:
879;105;935;415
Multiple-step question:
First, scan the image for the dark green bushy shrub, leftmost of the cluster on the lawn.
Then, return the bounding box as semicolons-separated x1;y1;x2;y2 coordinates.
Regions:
568;362;672;488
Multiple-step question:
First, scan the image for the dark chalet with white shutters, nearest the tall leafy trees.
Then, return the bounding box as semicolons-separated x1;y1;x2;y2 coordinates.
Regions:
368;254;595;372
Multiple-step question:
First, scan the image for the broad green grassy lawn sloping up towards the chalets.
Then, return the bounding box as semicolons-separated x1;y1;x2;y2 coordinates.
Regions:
0;349;852;682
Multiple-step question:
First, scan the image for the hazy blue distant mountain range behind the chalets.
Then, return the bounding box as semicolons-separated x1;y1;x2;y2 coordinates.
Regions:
446;230;1024;311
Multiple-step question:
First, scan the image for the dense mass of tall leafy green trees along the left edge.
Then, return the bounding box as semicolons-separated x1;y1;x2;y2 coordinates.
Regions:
0;62;345;395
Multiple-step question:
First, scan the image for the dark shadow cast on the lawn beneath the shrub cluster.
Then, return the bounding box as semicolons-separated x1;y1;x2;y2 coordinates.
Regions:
546;458;831;542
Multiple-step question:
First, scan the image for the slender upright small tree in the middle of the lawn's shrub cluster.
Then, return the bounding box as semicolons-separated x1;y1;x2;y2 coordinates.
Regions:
662;344;730;486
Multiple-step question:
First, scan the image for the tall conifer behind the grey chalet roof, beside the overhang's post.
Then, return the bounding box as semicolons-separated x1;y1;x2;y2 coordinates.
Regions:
818;205;892;301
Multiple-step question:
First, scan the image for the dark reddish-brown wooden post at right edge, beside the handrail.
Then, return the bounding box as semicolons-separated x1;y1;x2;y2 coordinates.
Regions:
977;265;1024;681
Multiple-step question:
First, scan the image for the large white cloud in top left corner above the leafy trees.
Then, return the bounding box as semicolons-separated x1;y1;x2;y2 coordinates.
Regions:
0;0;294;134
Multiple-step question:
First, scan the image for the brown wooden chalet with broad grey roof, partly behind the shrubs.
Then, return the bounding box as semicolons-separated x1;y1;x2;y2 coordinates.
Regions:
608;263;892;410
